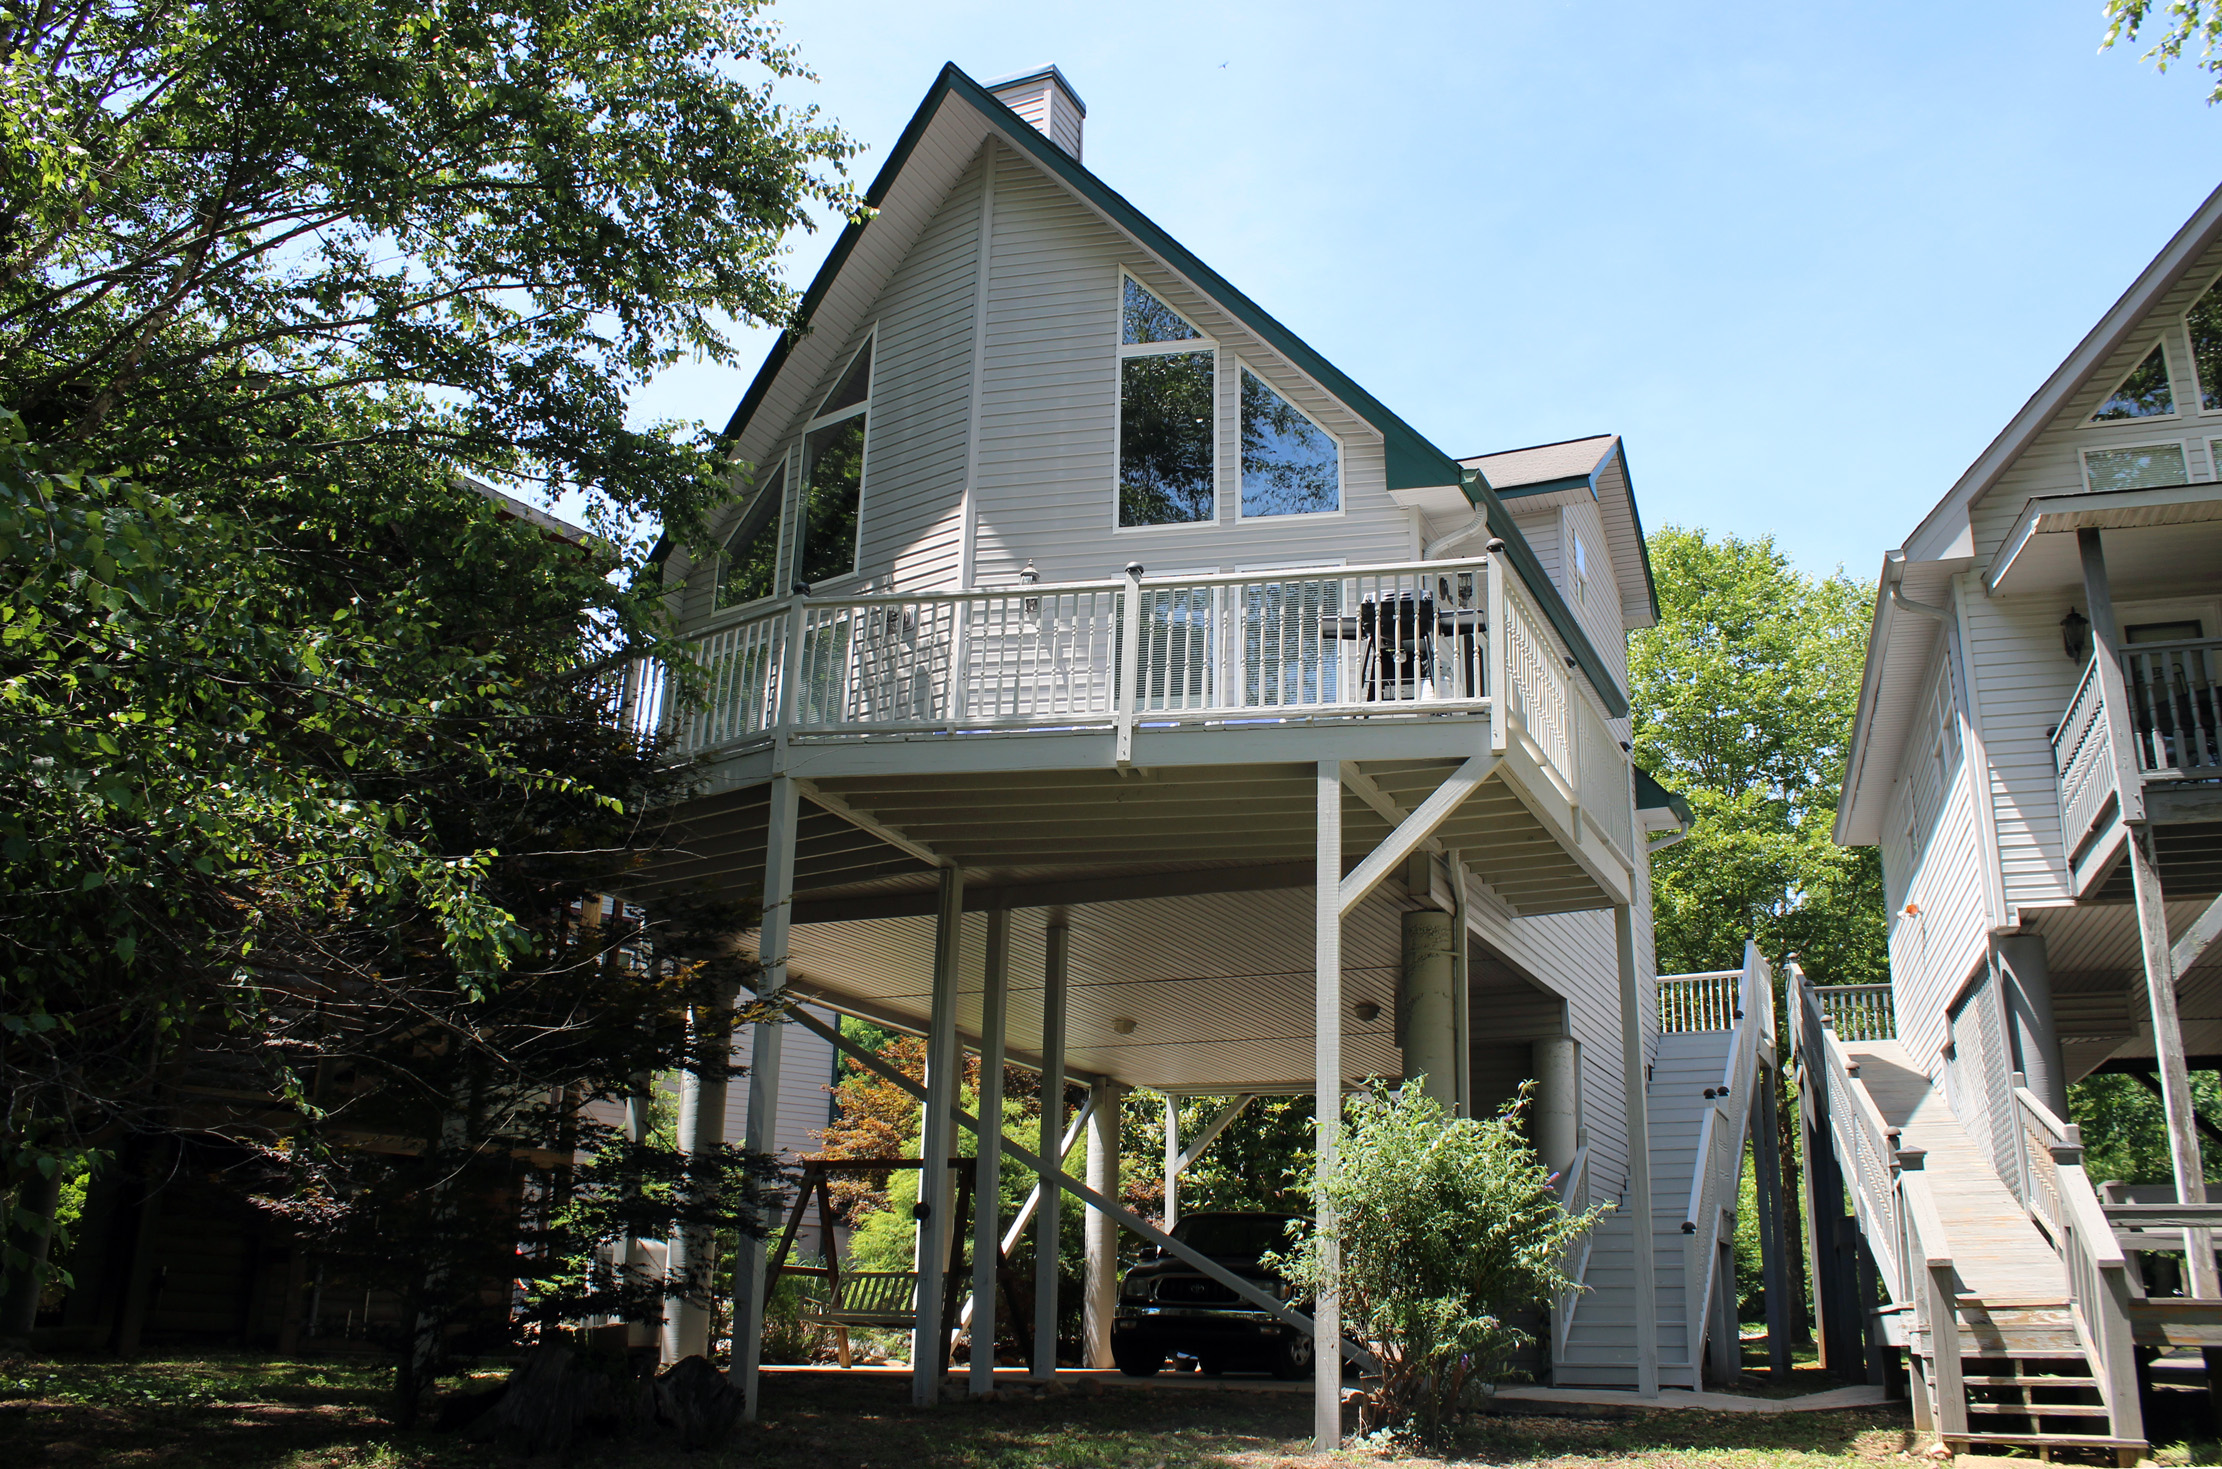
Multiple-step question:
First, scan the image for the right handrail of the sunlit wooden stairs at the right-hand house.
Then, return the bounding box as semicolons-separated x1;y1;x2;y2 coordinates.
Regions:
2013;1071;2144;1438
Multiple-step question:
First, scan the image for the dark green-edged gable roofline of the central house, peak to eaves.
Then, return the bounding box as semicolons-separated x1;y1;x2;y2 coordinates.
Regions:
711;62;1627;718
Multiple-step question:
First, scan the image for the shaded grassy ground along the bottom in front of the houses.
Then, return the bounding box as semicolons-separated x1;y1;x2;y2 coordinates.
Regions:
0;1356;1913;1469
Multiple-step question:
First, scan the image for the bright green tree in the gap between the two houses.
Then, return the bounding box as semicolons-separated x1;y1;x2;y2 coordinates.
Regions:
1629;527;1889;985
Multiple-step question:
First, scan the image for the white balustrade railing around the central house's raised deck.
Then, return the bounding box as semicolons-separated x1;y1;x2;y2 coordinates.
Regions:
653;556;1633;853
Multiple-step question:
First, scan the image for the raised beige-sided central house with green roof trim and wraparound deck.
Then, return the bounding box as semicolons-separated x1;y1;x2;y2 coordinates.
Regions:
649;67;1766;1431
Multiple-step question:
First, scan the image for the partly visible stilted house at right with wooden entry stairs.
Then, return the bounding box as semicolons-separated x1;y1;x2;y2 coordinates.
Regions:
1800;180;2222;1453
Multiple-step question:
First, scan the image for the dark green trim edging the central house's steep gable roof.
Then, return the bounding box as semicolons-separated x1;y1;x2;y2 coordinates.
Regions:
724;62;1629;718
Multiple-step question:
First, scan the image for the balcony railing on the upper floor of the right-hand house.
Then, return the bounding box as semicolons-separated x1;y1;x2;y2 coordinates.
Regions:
2053;638;2222;862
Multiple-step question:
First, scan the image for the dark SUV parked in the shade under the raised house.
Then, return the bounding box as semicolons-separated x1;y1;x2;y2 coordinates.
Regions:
1111;1213;1311;1378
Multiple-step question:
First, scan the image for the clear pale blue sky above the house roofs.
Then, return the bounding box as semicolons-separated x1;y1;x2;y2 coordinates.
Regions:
635;0;2222;580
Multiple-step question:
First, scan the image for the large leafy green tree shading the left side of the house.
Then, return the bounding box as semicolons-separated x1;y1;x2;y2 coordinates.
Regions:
0;0;855;1208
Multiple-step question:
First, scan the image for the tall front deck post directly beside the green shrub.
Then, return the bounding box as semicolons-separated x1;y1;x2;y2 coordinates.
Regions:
1311;760;1342;1453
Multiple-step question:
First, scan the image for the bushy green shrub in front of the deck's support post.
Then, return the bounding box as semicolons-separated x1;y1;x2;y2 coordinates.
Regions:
1280;1085;1604;1440
